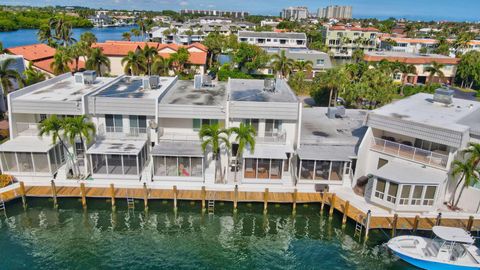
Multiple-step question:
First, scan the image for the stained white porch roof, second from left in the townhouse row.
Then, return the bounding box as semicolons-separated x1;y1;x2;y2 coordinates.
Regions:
87;139;147;155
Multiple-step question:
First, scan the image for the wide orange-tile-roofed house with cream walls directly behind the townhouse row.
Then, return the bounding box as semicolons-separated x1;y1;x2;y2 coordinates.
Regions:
92;40;208;75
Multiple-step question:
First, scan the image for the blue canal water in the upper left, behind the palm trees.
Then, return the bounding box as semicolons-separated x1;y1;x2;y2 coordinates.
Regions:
0;26;139;48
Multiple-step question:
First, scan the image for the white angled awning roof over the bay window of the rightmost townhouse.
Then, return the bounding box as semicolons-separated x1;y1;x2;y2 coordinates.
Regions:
372;160;447;185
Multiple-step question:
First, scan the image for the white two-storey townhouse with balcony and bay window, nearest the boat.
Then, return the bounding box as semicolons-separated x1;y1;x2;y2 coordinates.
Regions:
354;89;480;212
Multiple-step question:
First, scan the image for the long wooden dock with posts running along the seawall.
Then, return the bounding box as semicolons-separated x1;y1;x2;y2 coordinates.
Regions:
0;181;480;236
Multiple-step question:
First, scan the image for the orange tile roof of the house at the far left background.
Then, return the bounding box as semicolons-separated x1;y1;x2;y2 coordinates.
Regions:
6;43;85;77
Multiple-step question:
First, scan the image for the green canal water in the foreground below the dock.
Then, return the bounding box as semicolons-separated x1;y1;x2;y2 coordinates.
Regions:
0;199;409;269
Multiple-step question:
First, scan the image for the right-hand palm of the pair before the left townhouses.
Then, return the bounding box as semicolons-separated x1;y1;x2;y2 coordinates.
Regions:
64;115;96;175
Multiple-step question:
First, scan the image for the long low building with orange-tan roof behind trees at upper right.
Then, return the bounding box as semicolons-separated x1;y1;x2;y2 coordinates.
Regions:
363;51;460;84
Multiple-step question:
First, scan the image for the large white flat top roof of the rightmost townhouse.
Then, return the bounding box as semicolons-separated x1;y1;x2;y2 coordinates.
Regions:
370;93;480;131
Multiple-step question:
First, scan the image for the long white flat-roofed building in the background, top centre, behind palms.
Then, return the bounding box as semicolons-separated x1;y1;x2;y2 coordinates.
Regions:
238;31;307;49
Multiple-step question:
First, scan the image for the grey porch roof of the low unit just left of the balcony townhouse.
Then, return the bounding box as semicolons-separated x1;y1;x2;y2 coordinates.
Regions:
297;145;357;161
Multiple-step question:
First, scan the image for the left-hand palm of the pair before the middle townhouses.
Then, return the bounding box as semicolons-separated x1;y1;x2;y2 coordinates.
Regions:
198;124;230;182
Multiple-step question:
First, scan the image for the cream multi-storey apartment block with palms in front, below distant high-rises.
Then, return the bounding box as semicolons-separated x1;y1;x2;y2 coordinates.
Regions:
324;25;380;58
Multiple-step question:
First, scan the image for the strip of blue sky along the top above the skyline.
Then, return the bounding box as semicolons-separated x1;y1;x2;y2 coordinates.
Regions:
1;0;480;21
